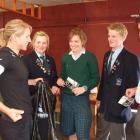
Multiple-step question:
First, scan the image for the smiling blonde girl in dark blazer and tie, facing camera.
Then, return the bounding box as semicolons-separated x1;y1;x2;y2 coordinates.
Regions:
23;31;59;140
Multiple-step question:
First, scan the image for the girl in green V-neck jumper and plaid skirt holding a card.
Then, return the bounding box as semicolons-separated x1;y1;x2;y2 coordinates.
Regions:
57;28;99;140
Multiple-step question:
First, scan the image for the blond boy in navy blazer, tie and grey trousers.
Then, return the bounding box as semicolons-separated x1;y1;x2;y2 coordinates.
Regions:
96;23;138;140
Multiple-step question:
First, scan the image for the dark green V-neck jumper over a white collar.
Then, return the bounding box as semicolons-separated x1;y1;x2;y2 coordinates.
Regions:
61;51;99;94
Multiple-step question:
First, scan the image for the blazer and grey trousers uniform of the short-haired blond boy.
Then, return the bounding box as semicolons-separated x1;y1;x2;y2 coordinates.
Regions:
96;48;138;140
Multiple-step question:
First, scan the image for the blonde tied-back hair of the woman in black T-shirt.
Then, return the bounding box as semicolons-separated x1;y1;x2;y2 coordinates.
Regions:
0;19;32;47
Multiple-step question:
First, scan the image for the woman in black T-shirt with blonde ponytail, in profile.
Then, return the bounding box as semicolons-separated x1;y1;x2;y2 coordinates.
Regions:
0;19;41;140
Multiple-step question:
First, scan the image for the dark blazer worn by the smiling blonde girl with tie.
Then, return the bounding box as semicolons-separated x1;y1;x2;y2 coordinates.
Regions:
22;51;58;94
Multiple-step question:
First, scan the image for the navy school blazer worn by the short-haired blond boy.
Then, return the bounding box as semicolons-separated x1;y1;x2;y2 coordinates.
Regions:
97;48;138;123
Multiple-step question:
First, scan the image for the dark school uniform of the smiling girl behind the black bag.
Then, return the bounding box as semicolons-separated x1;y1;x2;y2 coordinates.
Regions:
23;51;57;140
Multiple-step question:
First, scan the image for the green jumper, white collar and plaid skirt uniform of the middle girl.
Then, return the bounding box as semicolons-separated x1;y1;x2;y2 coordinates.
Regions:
60;49;99;140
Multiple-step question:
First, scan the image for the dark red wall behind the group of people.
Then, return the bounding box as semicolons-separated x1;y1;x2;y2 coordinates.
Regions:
0;0;140;72
